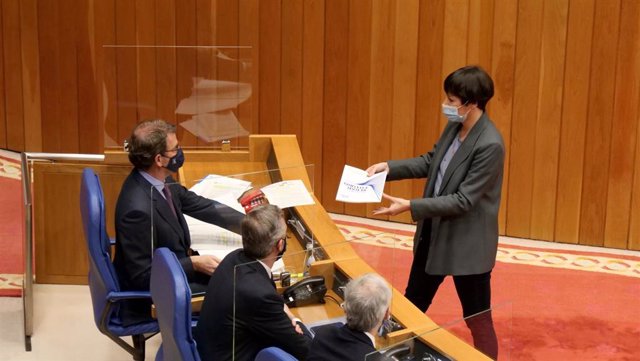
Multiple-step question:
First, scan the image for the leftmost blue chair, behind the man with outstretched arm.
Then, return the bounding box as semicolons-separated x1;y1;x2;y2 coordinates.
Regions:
80;168;159;360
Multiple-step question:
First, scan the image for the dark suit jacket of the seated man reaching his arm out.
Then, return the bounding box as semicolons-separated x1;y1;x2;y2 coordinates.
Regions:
113;169;244;324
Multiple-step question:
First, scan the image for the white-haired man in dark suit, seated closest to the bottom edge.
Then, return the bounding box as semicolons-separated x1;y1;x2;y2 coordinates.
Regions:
307;273;391;361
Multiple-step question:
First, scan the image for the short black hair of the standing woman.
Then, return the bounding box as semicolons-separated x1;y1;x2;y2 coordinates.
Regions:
444;65;493;110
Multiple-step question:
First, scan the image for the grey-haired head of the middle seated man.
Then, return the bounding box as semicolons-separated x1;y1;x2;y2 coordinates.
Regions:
241;204;287;259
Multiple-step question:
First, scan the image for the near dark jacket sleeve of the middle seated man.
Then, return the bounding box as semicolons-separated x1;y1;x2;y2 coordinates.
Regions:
251;293;311;360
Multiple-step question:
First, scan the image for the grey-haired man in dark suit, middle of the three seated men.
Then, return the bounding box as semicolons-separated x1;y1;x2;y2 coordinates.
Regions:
195;204;310;361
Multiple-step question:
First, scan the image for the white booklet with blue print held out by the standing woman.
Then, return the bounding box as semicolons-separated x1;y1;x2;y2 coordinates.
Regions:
336;165;387;203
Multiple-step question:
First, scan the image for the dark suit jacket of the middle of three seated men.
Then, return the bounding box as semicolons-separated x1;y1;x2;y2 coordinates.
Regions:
195;250;310;361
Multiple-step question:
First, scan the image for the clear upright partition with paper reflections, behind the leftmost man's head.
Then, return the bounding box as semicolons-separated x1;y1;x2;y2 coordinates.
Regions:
98;45;252;150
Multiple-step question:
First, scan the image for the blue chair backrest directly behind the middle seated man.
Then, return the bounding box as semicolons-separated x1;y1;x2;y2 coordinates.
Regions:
151;247;200;361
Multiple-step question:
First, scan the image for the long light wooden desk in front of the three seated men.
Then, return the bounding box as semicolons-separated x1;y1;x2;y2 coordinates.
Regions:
181;135;490;360
